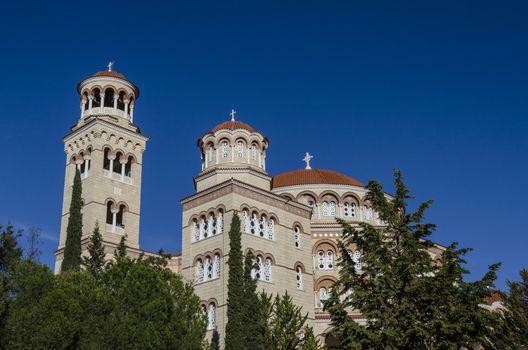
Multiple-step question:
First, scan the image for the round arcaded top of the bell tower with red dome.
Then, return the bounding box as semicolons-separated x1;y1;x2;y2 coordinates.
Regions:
77;62;139;123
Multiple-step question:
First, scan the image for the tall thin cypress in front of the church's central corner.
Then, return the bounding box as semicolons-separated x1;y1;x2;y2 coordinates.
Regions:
225;213;245;350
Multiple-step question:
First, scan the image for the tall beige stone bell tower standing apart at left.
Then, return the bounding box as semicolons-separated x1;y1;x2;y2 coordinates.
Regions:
55;63;148;272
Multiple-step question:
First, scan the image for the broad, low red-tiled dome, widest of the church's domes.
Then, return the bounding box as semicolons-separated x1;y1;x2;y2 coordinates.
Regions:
272;169;365;188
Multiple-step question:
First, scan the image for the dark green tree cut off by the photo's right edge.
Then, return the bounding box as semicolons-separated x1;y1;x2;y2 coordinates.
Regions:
496;269;528;350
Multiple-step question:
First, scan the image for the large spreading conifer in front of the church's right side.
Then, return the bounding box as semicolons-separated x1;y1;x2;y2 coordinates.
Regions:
325;171;499;349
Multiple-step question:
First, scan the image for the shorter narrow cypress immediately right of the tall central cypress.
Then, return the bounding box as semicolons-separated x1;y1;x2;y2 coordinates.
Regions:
242;252;266;350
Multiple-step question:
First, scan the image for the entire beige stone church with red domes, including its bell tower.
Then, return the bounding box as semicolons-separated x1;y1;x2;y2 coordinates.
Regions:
55;65;446;339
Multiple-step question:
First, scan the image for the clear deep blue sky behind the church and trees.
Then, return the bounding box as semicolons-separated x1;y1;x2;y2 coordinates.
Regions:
0;1;528;287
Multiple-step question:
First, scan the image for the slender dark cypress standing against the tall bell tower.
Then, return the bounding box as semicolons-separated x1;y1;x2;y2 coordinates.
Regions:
62;169;82;272
